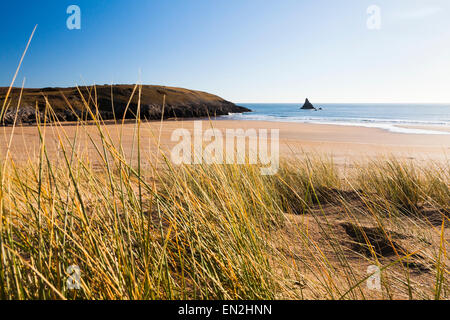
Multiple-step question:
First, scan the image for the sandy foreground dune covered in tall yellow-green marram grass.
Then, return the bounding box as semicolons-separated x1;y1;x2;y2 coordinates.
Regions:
0;85;450;299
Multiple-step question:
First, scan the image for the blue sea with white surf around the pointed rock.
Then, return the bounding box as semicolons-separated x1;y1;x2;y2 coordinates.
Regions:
221;103;450;135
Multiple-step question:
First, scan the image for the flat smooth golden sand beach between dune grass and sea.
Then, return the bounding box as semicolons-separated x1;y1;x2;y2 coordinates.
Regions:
0;120;450;163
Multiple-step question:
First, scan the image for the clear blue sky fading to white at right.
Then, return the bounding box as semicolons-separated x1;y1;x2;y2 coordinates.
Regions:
0;0;450;103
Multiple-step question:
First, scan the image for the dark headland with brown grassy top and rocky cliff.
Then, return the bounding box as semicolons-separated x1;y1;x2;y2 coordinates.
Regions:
0;85;251;125
